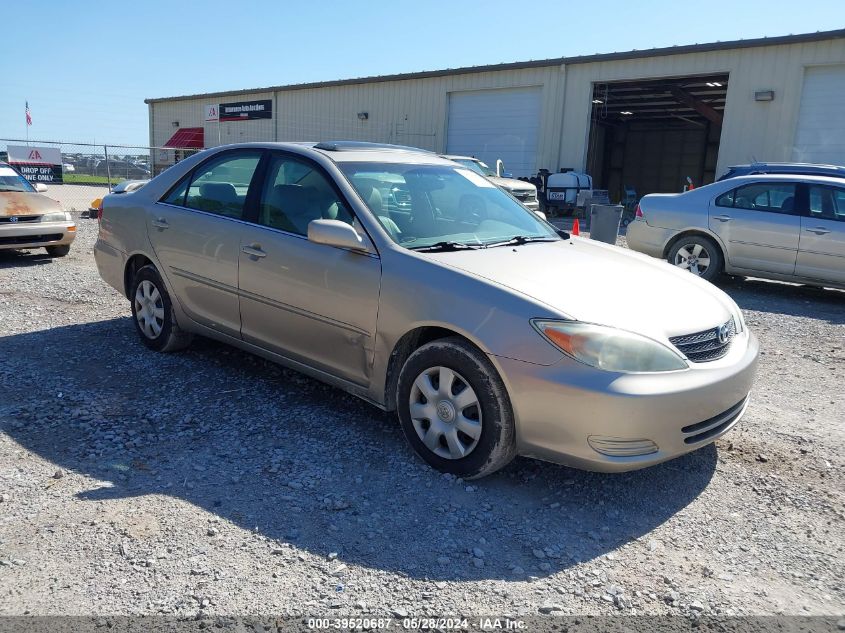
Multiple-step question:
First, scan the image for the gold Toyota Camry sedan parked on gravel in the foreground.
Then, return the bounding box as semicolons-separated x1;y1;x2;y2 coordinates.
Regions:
95;142;758;478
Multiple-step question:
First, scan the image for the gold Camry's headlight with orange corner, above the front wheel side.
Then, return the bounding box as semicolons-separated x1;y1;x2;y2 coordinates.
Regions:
531;320;687;373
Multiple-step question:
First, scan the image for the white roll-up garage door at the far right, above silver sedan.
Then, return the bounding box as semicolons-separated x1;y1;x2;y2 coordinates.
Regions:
792;65;845;165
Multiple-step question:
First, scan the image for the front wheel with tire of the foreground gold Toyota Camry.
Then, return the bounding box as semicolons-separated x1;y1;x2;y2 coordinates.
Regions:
396;337;516;479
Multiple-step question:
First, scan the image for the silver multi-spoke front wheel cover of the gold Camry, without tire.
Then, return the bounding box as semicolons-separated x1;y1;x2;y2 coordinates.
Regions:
409;366;481;459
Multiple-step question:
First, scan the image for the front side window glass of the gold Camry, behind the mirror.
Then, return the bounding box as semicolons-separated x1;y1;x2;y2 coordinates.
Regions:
258;155;353;235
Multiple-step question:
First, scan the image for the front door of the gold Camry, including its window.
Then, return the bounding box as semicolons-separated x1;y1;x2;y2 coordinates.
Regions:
239;153;381;386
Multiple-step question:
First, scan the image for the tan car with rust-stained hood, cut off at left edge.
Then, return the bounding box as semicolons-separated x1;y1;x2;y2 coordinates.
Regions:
0;162;76;257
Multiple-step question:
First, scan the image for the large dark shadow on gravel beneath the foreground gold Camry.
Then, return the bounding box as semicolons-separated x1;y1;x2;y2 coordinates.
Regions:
0;318;717;580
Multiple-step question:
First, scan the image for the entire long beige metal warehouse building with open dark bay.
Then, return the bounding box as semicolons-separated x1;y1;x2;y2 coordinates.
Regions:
146;29;845;198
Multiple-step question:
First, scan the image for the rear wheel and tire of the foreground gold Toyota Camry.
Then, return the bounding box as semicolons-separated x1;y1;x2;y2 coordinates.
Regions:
129;266;193;352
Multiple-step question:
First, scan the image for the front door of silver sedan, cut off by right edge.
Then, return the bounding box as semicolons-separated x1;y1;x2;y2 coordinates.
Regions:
795;184;845;284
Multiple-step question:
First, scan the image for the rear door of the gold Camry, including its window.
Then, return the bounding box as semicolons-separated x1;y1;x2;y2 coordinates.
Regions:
147;150;261;337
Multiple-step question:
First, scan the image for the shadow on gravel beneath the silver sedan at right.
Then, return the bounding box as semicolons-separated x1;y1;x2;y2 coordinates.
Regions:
718;276;845;325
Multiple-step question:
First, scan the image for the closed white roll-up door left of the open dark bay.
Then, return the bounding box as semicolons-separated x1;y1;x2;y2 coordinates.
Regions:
446;88;541;176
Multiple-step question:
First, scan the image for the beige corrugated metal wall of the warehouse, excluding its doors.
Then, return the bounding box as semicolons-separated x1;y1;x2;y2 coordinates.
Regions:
150;39;845;174
